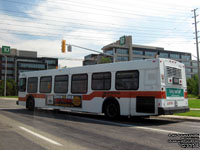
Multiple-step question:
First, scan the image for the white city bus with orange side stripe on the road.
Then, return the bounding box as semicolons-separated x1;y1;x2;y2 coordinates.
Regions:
17;58;189;119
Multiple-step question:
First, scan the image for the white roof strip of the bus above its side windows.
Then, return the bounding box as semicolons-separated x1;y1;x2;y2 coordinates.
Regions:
20;58;184;76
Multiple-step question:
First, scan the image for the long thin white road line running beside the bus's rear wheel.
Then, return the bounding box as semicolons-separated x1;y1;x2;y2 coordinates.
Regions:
76;116;186;134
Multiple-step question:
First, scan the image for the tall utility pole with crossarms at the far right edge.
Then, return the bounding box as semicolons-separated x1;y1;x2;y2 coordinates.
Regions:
192;8;200;98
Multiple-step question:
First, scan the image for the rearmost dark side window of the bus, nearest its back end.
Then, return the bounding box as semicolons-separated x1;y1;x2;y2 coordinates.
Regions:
115;70;139;90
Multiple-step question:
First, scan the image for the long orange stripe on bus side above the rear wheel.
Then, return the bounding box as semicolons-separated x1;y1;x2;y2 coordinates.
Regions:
83;91;166;100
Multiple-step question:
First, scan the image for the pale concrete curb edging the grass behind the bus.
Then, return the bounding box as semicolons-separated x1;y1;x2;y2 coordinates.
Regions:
159;115;200;122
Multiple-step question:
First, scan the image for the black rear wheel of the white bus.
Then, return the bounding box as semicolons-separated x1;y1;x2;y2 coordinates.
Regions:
104;102;120;119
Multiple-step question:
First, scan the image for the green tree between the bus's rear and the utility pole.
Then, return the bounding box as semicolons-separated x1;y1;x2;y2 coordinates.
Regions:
187;74;198;95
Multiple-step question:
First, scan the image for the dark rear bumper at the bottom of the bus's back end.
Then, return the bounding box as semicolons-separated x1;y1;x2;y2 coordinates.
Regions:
158;106;190;115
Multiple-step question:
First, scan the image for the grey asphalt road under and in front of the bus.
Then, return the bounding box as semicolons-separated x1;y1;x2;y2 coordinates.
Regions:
0;99;200;150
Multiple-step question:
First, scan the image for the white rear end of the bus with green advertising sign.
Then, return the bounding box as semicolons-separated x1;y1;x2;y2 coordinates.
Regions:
158;59;189;115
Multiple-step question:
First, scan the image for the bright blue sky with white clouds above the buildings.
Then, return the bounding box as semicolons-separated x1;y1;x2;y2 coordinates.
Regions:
0;0;200;67
